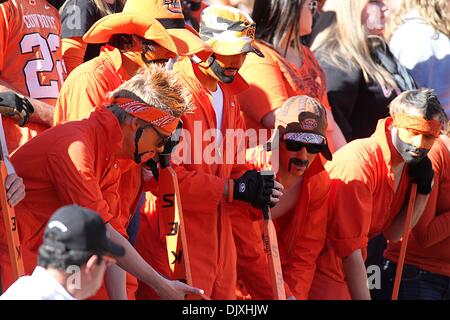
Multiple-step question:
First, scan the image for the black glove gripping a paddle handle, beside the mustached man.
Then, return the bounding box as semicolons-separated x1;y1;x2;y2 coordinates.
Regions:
233;170;274;209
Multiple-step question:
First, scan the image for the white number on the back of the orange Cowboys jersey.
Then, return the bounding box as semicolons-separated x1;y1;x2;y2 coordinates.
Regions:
20;33;65;99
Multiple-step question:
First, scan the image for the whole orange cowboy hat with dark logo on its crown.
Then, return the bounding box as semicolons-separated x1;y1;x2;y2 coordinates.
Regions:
83;0;212;60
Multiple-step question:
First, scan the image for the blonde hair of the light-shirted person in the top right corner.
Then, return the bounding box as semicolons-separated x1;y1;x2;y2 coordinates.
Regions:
389;0;450;37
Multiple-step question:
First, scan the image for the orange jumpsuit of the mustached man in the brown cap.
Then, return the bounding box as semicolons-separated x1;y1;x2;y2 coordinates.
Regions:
227;146;330;300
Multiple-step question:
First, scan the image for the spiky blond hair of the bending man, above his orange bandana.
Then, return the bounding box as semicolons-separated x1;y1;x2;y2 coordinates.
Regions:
107;64;194;117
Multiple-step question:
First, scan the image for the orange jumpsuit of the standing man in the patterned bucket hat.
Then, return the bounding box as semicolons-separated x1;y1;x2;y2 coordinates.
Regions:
136;58;247;299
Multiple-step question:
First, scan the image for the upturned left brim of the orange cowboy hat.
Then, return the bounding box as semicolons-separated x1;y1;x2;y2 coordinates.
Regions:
83;13;178;53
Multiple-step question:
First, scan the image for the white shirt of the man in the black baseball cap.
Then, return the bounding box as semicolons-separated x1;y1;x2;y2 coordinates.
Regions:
0;266;77;300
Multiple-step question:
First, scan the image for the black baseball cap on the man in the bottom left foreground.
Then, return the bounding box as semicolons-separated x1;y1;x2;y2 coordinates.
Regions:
44;205;125;257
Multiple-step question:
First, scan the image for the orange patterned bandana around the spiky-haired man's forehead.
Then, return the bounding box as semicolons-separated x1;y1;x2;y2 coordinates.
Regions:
112;98;179;133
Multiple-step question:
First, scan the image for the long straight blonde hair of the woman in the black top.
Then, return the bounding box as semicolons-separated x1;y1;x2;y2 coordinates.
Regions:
311;0;398;89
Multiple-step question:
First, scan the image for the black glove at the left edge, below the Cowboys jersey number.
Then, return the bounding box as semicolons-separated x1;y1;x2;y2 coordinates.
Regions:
0;91;34;127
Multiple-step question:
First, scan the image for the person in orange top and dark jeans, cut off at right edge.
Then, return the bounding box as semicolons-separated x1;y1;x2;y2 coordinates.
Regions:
381;117;450;300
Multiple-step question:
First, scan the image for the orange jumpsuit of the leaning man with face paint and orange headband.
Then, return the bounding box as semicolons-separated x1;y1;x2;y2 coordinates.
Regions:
310;118;411;300
